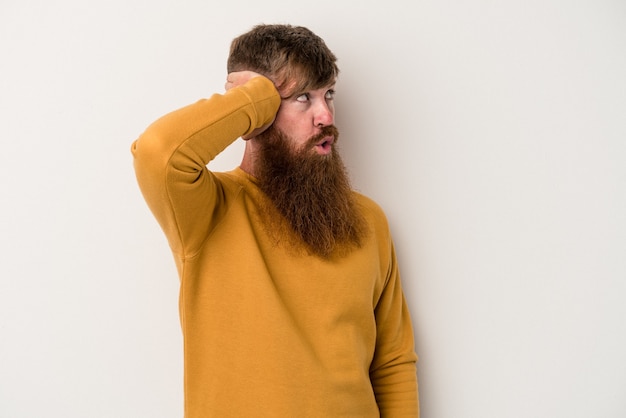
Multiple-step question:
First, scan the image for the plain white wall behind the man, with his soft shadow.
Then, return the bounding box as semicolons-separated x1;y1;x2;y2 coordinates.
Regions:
0;0;626;418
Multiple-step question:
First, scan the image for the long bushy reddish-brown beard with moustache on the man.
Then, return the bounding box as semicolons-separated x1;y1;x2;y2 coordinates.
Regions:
255;126;366;258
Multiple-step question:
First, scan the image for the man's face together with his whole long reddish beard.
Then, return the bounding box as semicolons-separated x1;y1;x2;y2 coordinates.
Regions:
254;84;366;257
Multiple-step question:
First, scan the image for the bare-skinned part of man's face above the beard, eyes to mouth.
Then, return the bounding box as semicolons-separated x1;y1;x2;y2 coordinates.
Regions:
274;85;336;155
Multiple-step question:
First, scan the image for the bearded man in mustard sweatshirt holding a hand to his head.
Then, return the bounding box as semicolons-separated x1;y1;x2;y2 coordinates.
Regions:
132;25;419;418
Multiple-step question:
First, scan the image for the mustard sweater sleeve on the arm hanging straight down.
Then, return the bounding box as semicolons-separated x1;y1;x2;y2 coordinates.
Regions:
370;238;419;418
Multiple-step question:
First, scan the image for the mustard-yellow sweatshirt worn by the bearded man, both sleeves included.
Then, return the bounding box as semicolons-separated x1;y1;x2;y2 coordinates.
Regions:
132;78;419;418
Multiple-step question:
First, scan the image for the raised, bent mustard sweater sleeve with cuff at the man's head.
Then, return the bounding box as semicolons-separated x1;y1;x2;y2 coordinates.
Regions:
131;77;280;262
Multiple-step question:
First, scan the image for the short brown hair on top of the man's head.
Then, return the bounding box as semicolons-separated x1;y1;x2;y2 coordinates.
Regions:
227;24;339;95
